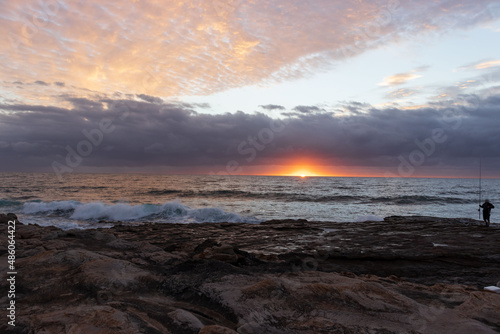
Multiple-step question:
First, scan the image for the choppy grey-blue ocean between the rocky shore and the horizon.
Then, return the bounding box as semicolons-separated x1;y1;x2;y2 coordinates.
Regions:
0;173;500;229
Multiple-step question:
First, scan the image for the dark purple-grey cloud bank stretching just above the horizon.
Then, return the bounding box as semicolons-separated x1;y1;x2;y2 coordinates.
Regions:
0;95;500;176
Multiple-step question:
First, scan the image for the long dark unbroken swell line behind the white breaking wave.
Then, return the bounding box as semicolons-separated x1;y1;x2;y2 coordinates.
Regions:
146;189;475;205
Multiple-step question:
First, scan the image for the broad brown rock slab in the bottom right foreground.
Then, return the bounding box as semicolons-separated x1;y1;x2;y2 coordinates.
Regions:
202;272;500;333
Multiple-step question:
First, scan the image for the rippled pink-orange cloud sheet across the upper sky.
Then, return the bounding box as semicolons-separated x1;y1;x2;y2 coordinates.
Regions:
0;0;496;98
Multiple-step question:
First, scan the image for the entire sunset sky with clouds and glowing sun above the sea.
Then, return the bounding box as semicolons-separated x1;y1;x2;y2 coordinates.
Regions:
0;0;500;180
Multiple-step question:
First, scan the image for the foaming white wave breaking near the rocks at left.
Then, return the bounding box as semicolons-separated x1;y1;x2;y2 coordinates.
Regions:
23;201;259;223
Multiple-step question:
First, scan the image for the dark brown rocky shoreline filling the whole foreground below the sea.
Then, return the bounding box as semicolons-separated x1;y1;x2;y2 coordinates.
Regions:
0;215;500;334
